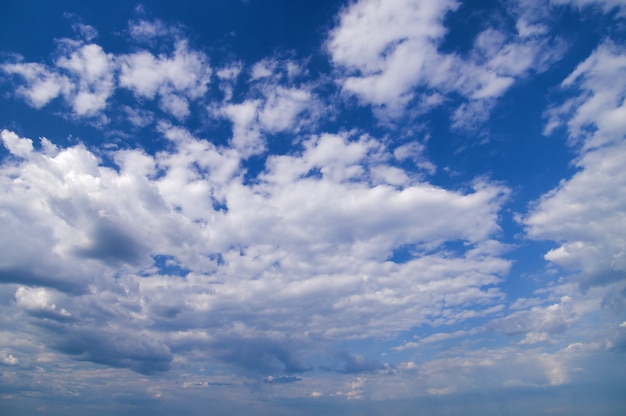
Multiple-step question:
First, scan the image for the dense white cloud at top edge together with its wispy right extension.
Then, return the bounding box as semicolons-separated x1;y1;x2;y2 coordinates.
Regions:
327;0;562;122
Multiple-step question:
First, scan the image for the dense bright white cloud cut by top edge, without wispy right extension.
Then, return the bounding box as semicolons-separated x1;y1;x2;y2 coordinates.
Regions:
327;0;457;111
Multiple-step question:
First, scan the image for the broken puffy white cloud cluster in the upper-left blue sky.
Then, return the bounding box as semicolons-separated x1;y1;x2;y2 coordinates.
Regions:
0;25;212;121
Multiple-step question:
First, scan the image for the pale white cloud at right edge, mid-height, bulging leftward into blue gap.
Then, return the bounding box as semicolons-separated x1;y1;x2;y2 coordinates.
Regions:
525;143;626;285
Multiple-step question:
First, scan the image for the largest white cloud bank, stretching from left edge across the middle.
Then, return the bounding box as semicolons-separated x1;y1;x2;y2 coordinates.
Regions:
1;125;509;372
